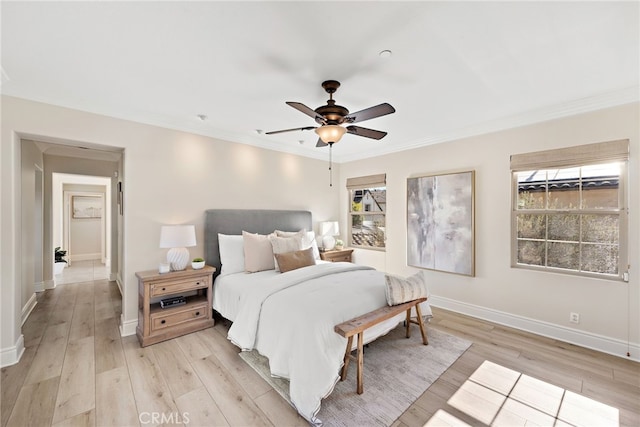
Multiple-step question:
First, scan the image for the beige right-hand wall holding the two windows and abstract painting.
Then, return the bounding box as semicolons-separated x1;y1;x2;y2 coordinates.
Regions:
339;104;640;359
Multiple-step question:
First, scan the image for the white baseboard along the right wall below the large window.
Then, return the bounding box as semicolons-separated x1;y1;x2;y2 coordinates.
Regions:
429;295;640;362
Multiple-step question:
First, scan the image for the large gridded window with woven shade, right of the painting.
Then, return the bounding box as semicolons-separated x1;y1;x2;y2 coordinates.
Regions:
511;140;629;279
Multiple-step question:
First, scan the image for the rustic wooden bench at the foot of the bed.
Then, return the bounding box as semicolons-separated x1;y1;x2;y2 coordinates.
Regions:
333;298;429;394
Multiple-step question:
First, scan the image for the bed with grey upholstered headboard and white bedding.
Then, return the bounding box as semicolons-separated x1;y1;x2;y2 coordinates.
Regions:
205;209;430;425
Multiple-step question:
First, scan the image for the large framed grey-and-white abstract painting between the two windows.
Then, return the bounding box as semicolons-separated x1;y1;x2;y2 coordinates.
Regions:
407;171;475;276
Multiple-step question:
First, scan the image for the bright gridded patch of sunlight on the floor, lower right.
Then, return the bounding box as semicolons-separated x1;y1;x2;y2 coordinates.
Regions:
425;361;620;427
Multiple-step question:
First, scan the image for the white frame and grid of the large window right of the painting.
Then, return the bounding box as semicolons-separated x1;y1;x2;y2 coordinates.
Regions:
511;140;629;281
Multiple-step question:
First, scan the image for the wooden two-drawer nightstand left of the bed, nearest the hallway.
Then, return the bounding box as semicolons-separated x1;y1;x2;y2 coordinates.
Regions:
136;266;216;347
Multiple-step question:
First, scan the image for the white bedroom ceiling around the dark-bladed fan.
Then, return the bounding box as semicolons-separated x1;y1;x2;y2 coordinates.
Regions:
1;1;640;162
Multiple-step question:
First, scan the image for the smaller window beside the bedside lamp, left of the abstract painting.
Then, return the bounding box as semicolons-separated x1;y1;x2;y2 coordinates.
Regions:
347;174;387;250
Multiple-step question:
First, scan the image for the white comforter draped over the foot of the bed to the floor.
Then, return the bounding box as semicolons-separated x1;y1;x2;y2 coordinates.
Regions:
229;263;430;424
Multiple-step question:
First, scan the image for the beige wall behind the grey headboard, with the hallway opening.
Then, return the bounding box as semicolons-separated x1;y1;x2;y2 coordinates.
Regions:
0;96;339;366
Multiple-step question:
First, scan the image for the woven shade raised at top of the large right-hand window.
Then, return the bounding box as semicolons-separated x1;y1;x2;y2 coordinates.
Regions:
511;139;629;171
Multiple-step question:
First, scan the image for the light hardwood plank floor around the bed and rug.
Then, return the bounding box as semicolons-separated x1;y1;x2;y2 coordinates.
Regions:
0;280;640;427
